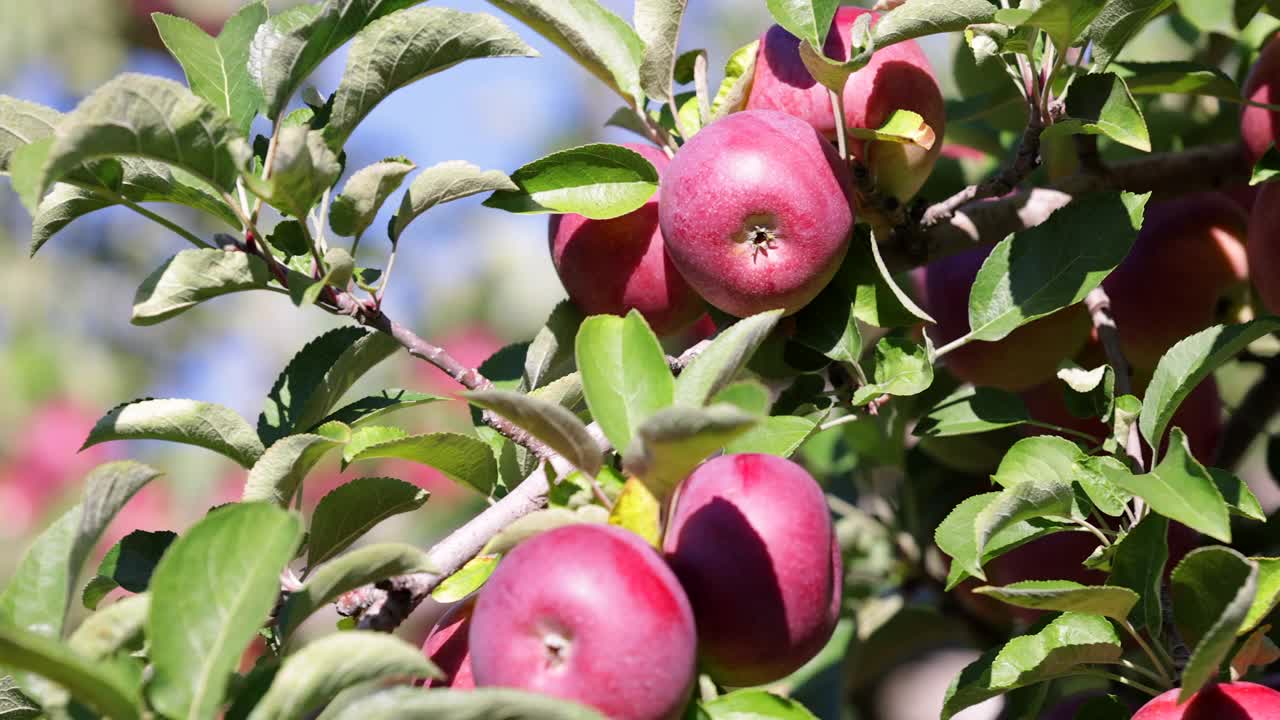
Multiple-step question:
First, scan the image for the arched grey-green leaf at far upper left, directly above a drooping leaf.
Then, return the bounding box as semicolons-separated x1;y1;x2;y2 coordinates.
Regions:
35;73;239;197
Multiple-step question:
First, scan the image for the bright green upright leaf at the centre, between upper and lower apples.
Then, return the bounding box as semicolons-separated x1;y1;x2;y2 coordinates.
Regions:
575;310;676;448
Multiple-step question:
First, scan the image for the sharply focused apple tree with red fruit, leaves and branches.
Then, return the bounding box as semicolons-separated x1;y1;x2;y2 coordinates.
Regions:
0;0;1280;720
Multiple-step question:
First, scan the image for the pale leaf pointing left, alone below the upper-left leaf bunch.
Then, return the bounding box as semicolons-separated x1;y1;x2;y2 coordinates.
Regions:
132;250;271;325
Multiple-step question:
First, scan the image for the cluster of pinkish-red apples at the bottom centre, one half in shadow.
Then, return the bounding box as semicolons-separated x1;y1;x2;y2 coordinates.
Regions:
424;454;842;720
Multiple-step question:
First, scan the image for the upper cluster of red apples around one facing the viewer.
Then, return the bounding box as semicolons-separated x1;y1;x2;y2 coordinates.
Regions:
549;8;946;336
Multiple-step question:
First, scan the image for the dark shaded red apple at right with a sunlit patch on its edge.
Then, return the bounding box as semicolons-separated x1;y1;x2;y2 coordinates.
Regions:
1102;192;1249;370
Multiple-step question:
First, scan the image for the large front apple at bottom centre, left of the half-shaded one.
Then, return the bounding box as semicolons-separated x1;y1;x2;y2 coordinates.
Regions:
470;524;696;720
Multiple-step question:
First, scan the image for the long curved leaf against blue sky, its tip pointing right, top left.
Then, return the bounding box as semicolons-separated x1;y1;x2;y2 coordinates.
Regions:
324;8;538;147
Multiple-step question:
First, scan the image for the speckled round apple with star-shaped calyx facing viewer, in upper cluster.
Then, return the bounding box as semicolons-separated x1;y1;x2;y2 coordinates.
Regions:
658;110;854;318
